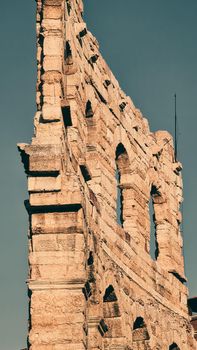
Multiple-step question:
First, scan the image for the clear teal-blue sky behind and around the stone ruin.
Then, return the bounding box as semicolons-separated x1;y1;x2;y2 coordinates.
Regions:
0;0;197;350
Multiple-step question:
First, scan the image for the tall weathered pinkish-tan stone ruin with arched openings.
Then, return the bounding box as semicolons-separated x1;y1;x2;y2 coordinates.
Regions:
18;0;196;350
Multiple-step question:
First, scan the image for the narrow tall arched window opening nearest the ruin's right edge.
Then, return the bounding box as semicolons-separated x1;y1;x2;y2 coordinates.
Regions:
149;185;159;260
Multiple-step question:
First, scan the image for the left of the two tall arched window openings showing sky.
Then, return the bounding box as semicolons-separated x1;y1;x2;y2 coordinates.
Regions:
115;143;129;227
